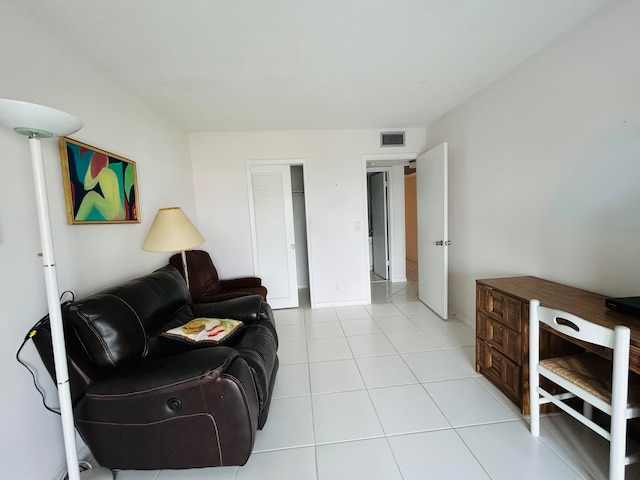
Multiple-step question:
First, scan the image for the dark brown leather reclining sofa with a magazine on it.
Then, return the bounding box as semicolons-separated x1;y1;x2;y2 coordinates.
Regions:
33;265;278;470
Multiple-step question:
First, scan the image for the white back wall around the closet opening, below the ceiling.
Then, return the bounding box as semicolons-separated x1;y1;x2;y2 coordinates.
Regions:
190;128;425;307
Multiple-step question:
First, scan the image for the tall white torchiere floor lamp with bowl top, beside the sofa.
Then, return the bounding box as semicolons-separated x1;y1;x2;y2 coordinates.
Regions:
0;99;113;480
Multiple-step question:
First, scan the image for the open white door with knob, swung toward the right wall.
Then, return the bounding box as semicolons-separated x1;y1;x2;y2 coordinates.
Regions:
416;143;451;320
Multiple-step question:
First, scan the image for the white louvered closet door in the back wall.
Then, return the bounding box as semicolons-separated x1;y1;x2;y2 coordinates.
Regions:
250;165;298;308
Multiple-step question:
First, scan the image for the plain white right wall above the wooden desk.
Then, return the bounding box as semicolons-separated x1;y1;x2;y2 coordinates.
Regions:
428;0;640;322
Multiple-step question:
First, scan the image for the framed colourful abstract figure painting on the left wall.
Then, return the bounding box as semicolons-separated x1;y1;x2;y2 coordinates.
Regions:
59;137;140;225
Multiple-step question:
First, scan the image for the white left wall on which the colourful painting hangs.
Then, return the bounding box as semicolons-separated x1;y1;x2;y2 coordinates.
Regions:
0;5;196;480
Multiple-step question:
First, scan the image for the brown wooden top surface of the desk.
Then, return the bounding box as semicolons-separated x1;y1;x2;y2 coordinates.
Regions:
478;277;640;346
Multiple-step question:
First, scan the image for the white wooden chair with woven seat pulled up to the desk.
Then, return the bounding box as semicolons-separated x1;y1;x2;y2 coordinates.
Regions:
529;300;640;480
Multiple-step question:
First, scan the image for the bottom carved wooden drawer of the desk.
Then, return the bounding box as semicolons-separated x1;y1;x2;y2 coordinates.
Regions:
476;339;523;408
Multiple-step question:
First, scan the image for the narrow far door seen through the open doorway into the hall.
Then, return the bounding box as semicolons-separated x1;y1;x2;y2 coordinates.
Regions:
369;172;389;280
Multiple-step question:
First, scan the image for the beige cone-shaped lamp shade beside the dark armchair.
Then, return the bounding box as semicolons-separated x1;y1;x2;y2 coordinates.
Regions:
142;207;204;252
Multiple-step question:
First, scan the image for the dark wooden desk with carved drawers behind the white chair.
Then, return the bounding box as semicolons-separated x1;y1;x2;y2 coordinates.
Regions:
476;277;640;415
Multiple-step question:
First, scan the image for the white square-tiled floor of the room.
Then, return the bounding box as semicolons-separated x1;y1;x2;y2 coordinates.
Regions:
116;272;640;480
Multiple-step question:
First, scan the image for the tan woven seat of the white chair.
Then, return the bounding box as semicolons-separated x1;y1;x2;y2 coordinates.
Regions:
540;353;640;406
